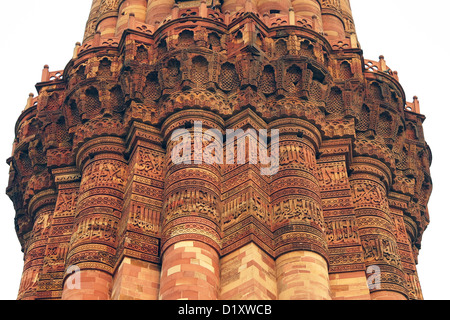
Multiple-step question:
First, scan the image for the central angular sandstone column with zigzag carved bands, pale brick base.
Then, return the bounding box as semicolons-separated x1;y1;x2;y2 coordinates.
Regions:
220;109;277;300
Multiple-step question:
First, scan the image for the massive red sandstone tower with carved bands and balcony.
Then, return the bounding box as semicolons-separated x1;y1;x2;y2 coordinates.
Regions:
7;0;432;300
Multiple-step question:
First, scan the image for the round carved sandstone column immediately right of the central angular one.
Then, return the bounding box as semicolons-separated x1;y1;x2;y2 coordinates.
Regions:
269;119;330;300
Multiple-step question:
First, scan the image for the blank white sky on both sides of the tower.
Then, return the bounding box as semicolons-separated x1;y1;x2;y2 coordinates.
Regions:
0;0;450;300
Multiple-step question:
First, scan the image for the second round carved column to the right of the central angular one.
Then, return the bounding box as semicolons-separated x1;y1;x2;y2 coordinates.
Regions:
350;157;407;300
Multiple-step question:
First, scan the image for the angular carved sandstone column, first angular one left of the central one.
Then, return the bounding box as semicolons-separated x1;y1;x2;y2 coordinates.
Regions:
112;122;165;300
